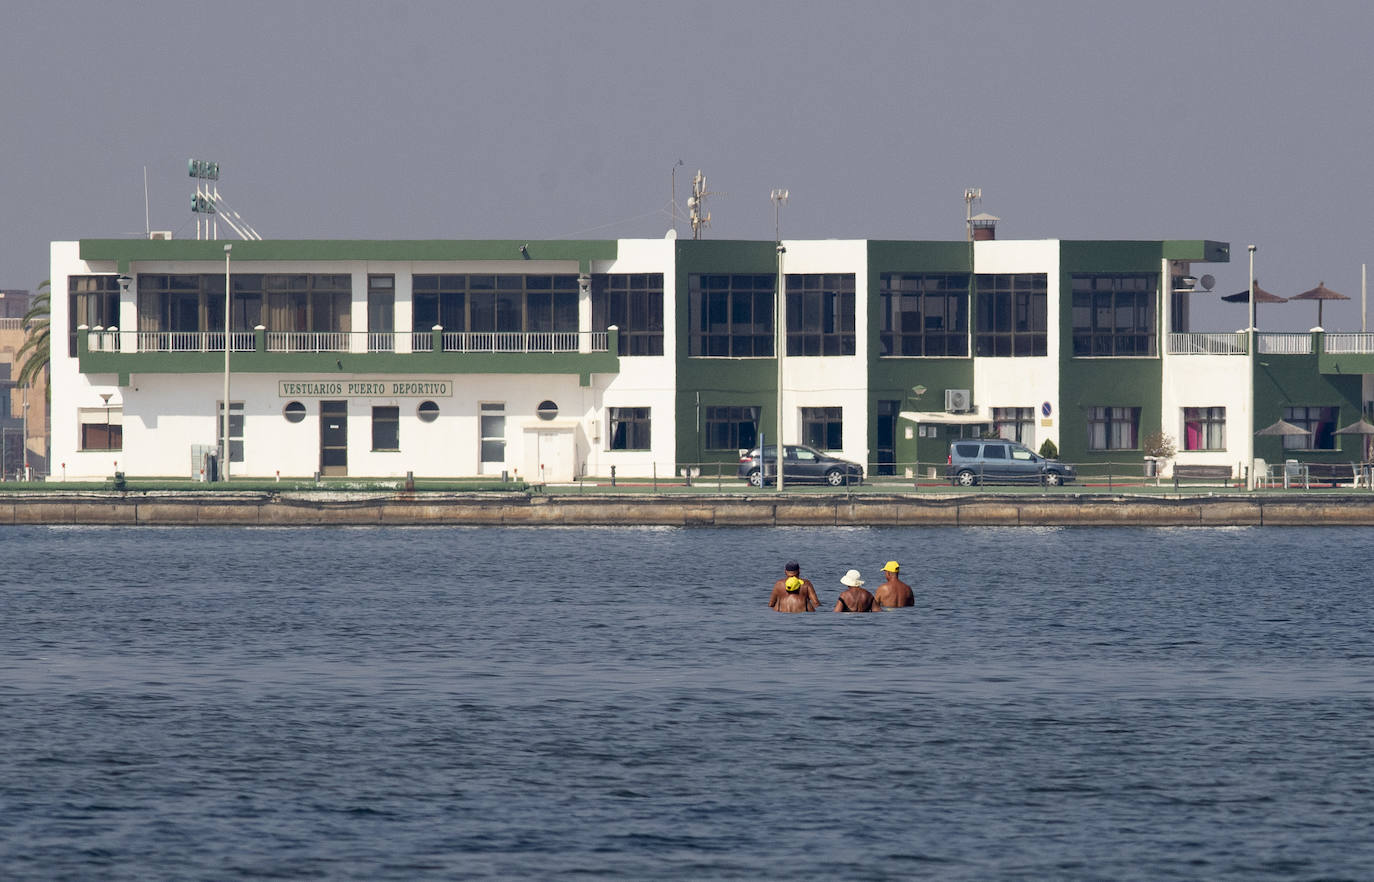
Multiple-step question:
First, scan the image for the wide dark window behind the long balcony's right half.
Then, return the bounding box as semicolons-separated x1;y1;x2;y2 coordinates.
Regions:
411;275;577;334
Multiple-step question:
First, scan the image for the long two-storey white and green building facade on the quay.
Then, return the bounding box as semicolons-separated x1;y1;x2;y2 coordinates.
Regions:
51;238;1374;481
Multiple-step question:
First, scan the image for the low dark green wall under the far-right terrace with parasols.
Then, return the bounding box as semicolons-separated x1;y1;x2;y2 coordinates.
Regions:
1258;340;1363;463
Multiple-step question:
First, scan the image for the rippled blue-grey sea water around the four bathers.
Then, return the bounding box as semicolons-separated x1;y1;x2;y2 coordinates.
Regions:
0;528;1374;879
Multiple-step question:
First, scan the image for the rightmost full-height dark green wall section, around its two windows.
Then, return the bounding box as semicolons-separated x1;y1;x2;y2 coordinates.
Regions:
1058;242;1165;463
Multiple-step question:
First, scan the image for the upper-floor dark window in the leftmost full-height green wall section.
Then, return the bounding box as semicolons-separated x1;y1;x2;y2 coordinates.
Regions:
687;275;776;359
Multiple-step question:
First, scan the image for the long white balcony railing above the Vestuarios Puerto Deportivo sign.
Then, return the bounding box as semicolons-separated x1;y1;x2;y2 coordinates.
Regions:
88;328;610;353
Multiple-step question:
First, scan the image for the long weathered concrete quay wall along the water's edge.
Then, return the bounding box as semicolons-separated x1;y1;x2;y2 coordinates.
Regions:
0;492;1374;526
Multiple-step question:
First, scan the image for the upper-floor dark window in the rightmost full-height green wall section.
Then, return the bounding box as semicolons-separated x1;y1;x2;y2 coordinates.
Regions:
1072;272;1160;356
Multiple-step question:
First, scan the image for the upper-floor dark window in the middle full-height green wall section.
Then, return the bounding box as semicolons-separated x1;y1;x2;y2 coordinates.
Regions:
878;272;969;357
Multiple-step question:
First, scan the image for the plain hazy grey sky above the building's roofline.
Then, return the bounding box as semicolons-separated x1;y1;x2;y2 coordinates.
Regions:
0;0;1374;330
